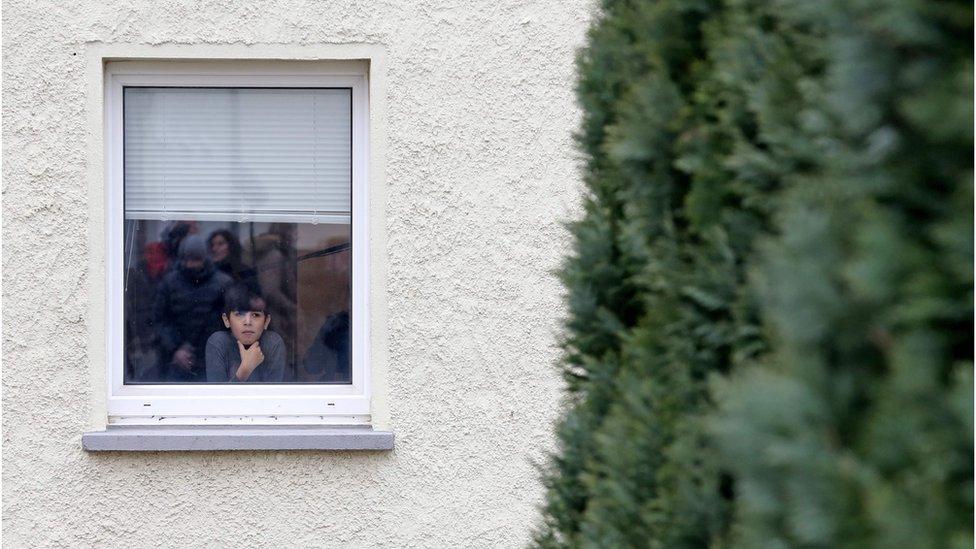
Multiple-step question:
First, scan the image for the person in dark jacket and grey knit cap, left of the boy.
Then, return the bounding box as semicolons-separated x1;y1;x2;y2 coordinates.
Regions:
153;235;233;382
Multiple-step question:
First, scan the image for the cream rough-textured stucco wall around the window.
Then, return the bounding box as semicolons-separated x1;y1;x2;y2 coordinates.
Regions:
2;0;590;547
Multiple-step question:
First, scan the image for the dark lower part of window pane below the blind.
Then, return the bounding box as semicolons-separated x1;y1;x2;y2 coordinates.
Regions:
124;220;352;383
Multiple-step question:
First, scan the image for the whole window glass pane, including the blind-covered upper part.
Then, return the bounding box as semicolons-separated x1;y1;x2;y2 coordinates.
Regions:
123;88;352;384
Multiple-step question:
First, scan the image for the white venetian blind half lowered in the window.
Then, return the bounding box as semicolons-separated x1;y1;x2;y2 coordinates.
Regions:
123;87;352;222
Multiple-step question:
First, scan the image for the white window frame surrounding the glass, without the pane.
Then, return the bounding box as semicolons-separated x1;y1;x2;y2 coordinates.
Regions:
104;61;371;424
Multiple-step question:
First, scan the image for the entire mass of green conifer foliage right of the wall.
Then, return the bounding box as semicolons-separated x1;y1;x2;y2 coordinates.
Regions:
535;0;973;547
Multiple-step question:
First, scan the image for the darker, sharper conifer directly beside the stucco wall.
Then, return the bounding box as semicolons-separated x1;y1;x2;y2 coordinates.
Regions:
536;0;795;547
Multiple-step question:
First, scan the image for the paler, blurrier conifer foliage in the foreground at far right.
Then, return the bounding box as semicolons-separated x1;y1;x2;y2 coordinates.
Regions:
712;0;973;548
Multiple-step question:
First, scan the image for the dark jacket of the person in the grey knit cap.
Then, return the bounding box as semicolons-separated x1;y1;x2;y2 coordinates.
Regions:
153;261;232;381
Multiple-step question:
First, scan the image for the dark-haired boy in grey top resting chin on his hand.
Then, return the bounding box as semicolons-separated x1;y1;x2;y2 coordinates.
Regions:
207;284;285;383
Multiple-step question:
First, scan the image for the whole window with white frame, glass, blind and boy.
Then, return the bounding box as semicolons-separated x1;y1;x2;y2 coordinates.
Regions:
106;62;370;423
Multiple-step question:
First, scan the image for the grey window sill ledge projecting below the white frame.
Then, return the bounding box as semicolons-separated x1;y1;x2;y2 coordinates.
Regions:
81;425;393;452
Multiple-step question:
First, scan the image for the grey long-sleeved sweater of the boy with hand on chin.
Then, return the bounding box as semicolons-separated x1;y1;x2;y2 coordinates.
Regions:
207;330;285;383
